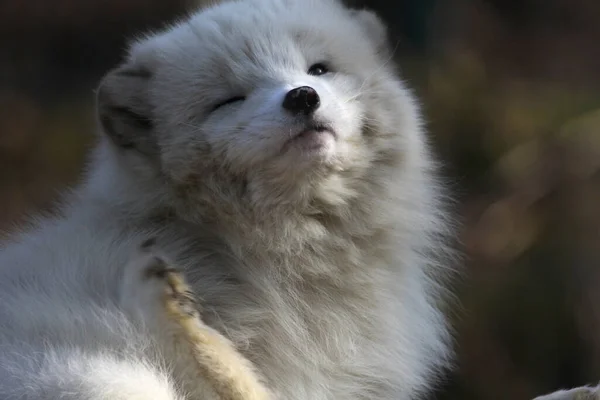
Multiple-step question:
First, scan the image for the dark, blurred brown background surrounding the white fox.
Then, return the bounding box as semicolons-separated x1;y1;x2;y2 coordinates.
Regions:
0;0;600;400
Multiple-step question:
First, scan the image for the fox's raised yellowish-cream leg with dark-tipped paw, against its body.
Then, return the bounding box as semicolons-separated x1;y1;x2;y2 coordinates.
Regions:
124;241;271;400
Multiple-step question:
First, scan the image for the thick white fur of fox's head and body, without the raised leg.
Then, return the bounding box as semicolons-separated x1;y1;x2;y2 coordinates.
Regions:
0;0;448;400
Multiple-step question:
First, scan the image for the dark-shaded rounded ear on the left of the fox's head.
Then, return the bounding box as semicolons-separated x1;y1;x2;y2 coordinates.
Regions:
96;62;156;154
